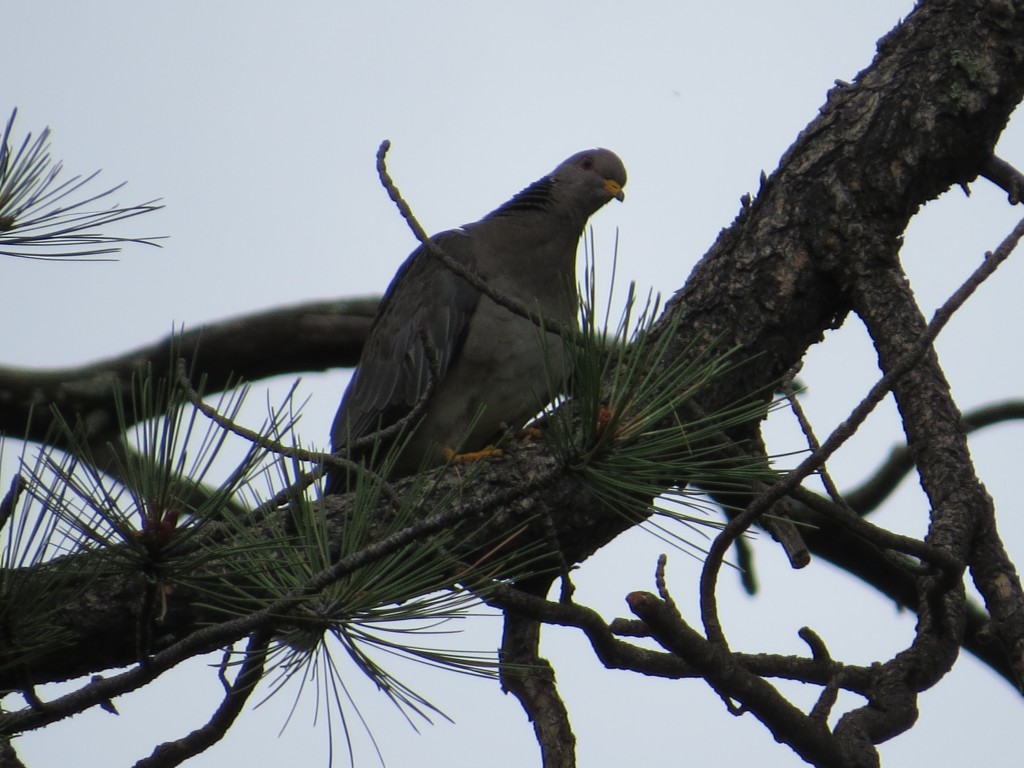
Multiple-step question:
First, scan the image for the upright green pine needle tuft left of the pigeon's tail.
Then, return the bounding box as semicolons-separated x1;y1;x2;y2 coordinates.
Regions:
23;350;278;583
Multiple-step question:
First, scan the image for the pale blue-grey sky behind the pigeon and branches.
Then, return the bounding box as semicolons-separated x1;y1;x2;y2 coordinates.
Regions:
0;0;1024;768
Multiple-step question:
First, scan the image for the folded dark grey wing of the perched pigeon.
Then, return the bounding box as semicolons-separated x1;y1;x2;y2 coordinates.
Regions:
331;229;480;451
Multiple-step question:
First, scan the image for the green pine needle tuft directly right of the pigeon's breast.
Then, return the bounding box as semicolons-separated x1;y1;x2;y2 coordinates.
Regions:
547;245;774;552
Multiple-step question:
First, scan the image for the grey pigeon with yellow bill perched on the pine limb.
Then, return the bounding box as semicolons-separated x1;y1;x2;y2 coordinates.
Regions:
326;148;626;494
